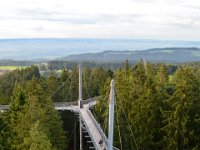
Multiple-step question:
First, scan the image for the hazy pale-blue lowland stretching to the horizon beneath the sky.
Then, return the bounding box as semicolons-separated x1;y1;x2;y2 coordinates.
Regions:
0;38;200;61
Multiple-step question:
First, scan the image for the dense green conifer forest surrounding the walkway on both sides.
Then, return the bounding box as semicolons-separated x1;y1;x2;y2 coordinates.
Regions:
0;61;200;150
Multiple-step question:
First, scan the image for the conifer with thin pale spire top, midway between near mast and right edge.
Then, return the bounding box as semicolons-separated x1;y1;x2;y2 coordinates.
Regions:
130;64;162;149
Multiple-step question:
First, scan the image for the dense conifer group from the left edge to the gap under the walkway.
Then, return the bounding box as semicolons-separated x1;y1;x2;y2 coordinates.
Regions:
0;66;67;150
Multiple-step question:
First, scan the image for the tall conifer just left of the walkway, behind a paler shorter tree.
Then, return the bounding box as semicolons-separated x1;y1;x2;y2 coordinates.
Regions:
27;79;66;150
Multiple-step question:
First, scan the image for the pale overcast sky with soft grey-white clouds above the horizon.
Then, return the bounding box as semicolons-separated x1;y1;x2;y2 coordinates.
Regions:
0;0;200;41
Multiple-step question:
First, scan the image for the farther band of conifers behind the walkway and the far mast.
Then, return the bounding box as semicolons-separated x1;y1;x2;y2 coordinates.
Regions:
0;66;113;104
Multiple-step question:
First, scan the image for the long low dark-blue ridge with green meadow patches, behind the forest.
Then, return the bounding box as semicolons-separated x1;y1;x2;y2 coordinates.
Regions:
59;47;200;63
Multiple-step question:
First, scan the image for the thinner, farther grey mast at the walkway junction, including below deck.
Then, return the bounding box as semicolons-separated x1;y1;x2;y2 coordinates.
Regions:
78;64;83;150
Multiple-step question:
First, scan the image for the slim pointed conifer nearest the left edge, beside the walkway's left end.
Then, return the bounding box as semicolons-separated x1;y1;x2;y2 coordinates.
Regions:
9;85;30;149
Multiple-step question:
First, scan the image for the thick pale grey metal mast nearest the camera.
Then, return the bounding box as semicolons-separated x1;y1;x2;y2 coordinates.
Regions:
108;80;115;150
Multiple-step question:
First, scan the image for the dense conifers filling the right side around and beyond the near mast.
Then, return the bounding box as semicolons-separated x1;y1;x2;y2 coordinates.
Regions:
95;62;200;150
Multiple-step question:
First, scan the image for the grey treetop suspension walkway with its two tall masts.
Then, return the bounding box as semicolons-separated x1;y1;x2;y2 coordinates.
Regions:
0;65;119;150
